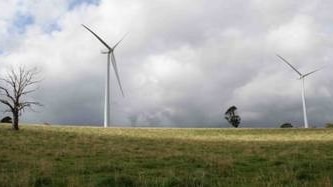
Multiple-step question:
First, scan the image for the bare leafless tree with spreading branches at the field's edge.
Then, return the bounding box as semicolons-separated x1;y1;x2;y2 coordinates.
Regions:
0;67;42;130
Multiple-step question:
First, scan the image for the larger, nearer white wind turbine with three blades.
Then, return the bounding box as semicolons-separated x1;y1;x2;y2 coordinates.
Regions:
82;24;126;127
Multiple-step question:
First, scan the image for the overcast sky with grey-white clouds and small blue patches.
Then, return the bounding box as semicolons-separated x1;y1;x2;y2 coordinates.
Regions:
0;0;333;127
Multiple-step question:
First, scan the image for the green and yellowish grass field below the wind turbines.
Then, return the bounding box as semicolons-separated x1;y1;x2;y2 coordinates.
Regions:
0;125;333;187
